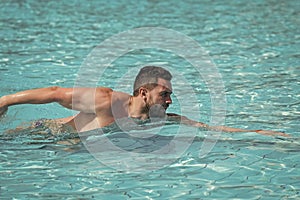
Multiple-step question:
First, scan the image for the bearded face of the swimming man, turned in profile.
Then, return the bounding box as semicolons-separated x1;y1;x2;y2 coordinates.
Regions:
147;78;172;110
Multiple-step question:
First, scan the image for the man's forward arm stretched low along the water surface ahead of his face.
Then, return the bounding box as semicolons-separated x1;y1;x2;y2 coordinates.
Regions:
168;114;290;137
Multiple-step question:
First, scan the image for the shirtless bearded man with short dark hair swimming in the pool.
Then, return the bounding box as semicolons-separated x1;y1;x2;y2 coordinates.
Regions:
0;66;288;136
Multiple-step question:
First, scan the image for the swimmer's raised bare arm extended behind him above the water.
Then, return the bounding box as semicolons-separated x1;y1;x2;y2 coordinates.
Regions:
0;87;111;116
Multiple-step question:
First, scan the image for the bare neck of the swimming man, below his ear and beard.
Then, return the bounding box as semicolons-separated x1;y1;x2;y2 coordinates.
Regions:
128;96;149;120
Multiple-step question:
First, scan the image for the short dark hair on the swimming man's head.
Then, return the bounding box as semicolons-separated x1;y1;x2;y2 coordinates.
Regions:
133;66;172;96
